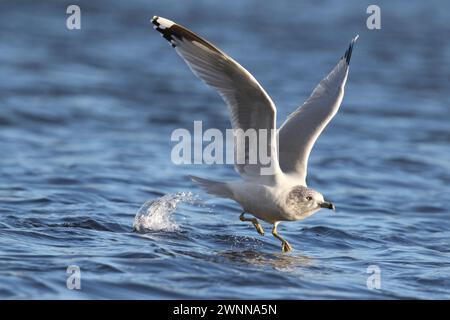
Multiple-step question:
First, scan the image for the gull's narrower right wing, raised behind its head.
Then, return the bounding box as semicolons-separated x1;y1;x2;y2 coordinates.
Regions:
278;36;358;185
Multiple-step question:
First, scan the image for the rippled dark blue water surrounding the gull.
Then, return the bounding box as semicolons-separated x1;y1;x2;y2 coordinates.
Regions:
0;0;450;299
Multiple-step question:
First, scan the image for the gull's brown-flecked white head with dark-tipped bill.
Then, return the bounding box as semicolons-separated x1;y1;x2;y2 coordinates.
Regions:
286;186;335;215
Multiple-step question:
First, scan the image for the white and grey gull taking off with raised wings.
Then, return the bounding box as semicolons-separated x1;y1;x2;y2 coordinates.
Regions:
151;16;358;252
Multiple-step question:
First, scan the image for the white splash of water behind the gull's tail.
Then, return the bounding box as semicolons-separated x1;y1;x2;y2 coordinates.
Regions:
133;192;198;233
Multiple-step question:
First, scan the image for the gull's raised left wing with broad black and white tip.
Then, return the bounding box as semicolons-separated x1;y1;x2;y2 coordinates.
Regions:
152;16;281;179
